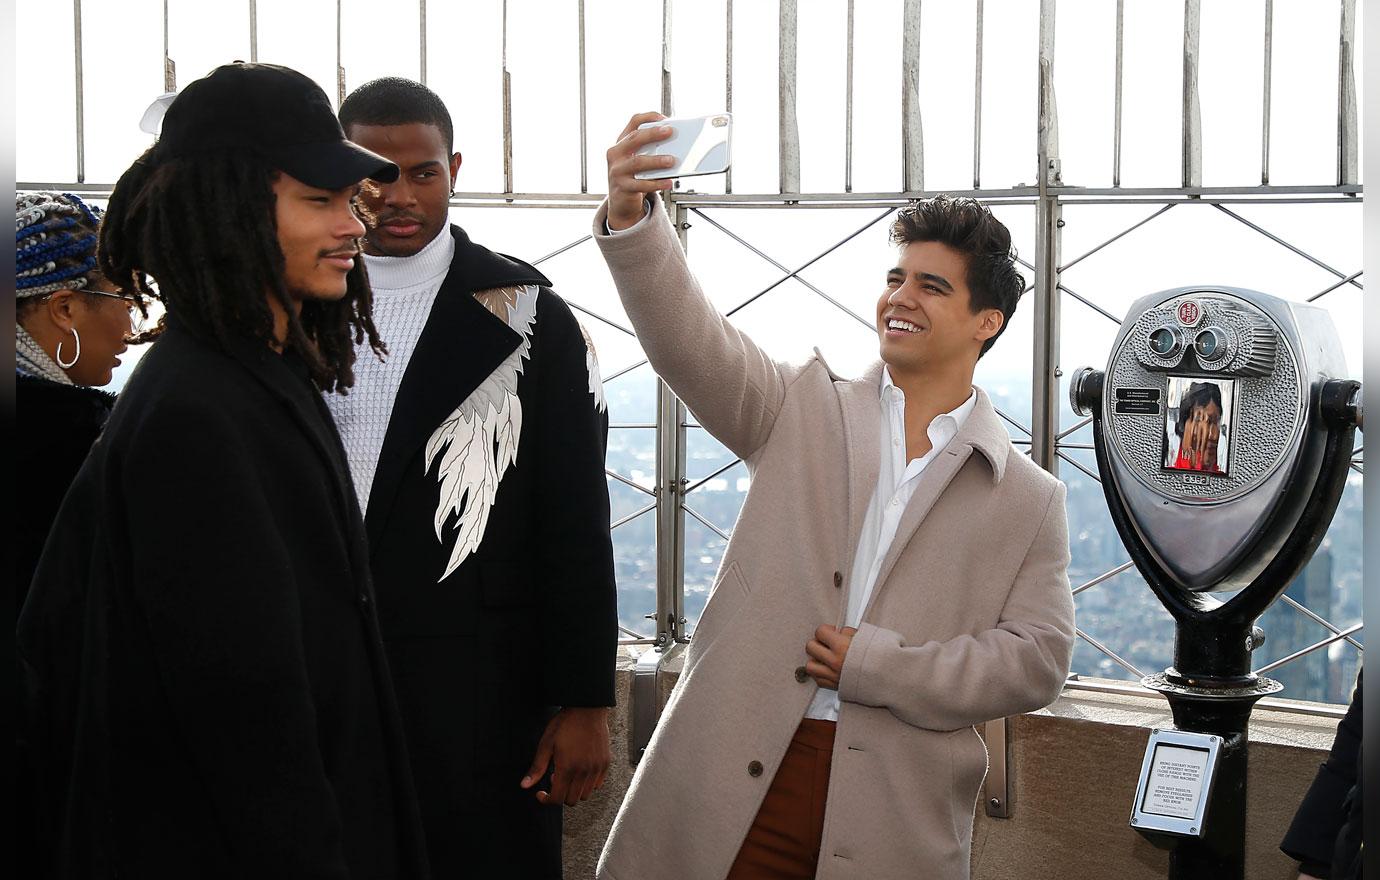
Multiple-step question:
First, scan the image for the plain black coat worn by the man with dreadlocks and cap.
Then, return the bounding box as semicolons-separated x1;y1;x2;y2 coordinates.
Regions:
18;324;426;879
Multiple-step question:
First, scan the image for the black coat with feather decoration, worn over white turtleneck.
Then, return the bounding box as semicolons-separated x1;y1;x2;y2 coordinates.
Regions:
366;228;617;877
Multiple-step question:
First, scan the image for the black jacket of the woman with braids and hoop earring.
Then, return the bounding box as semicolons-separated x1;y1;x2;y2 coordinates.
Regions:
14;374;115;617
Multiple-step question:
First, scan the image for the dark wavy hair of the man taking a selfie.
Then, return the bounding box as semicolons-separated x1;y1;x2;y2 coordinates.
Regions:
891;194;1025;357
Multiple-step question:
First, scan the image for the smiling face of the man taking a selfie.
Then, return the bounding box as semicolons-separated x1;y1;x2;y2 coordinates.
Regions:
876;241;1002;374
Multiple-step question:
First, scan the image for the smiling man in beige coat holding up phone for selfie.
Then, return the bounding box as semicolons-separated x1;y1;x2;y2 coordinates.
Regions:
595;113;1074;880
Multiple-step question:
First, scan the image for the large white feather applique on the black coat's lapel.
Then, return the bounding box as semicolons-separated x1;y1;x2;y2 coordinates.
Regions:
425;286;537;581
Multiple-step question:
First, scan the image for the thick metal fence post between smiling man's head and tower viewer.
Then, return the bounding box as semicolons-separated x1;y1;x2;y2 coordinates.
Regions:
1031;0;1064;473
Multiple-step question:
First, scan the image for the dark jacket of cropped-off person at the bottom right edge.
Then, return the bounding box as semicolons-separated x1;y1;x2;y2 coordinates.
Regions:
1279;674;1365;880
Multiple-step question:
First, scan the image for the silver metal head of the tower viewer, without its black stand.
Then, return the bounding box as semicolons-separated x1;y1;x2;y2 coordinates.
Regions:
1070;287;1361;592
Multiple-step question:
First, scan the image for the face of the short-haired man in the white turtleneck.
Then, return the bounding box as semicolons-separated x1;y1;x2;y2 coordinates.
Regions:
345;123;460;257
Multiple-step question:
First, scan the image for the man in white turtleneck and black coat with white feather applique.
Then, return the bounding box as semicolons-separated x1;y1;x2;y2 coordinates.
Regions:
328;79;617;879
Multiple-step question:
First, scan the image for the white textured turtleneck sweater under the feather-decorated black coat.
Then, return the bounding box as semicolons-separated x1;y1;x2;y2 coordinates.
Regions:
326;228;455;510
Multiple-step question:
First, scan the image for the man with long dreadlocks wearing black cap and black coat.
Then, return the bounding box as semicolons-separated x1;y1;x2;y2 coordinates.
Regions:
18;63;428;879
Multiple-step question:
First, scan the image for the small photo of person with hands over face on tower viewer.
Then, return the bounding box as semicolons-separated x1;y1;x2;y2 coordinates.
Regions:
1165;377;1236;476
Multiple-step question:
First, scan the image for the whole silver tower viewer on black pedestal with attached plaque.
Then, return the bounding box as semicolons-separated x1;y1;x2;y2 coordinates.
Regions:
1070;287;1362;880
